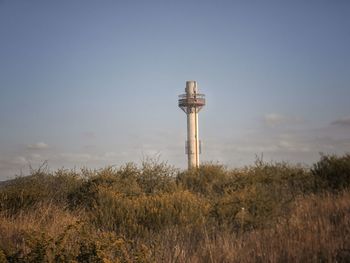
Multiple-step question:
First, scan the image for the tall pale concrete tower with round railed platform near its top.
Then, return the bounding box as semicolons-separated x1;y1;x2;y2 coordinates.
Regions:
179;80;205;169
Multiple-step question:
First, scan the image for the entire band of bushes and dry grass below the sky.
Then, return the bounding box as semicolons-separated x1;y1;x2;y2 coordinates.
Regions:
0;155;350;262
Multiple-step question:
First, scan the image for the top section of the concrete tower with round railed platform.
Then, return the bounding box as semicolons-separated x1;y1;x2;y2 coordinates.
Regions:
179;80;205;114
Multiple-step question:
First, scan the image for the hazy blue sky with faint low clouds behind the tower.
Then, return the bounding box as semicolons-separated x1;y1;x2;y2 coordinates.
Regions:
0;0;350;180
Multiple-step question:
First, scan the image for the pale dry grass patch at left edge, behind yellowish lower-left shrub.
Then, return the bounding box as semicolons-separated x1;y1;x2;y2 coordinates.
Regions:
0;203;83;258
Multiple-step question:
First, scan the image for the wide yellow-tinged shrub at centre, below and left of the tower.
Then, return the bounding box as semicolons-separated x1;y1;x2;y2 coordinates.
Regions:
90;187;209;236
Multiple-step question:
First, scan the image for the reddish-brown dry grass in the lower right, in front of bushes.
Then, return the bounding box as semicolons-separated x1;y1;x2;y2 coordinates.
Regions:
157;192;350;262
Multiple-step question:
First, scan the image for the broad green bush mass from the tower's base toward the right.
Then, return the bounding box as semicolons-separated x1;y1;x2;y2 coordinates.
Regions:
177;161;315;231
